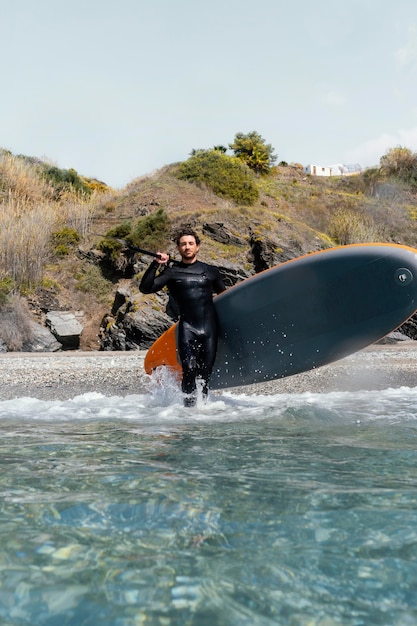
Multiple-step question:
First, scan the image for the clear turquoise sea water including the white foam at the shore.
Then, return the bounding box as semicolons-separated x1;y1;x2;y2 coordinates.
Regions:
0;370;417;626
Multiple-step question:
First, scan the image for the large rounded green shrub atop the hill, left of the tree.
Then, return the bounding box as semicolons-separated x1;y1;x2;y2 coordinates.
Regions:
177;150;259;206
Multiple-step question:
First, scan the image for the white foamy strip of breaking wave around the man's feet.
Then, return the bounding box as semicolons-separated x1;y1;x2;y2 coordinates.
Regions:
0;380;417;426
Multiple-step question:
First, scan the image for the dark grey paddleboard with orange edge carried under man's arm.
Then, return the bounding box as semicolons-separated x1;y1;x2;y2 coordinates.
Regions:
144;243;417;389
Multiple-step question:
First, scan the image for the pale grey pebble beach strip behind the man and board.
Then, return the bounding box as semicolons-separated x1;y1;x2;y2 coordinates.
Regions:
0;340;417;401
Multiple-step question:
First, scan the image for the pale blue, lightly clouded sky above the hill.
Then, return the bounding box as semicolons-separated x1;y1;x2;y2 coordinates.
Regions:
0;0;417;189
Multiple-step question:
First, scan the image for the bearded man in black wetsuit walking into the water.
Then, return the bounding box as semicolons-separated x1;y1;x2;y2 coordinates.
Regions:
139;229;226;406
